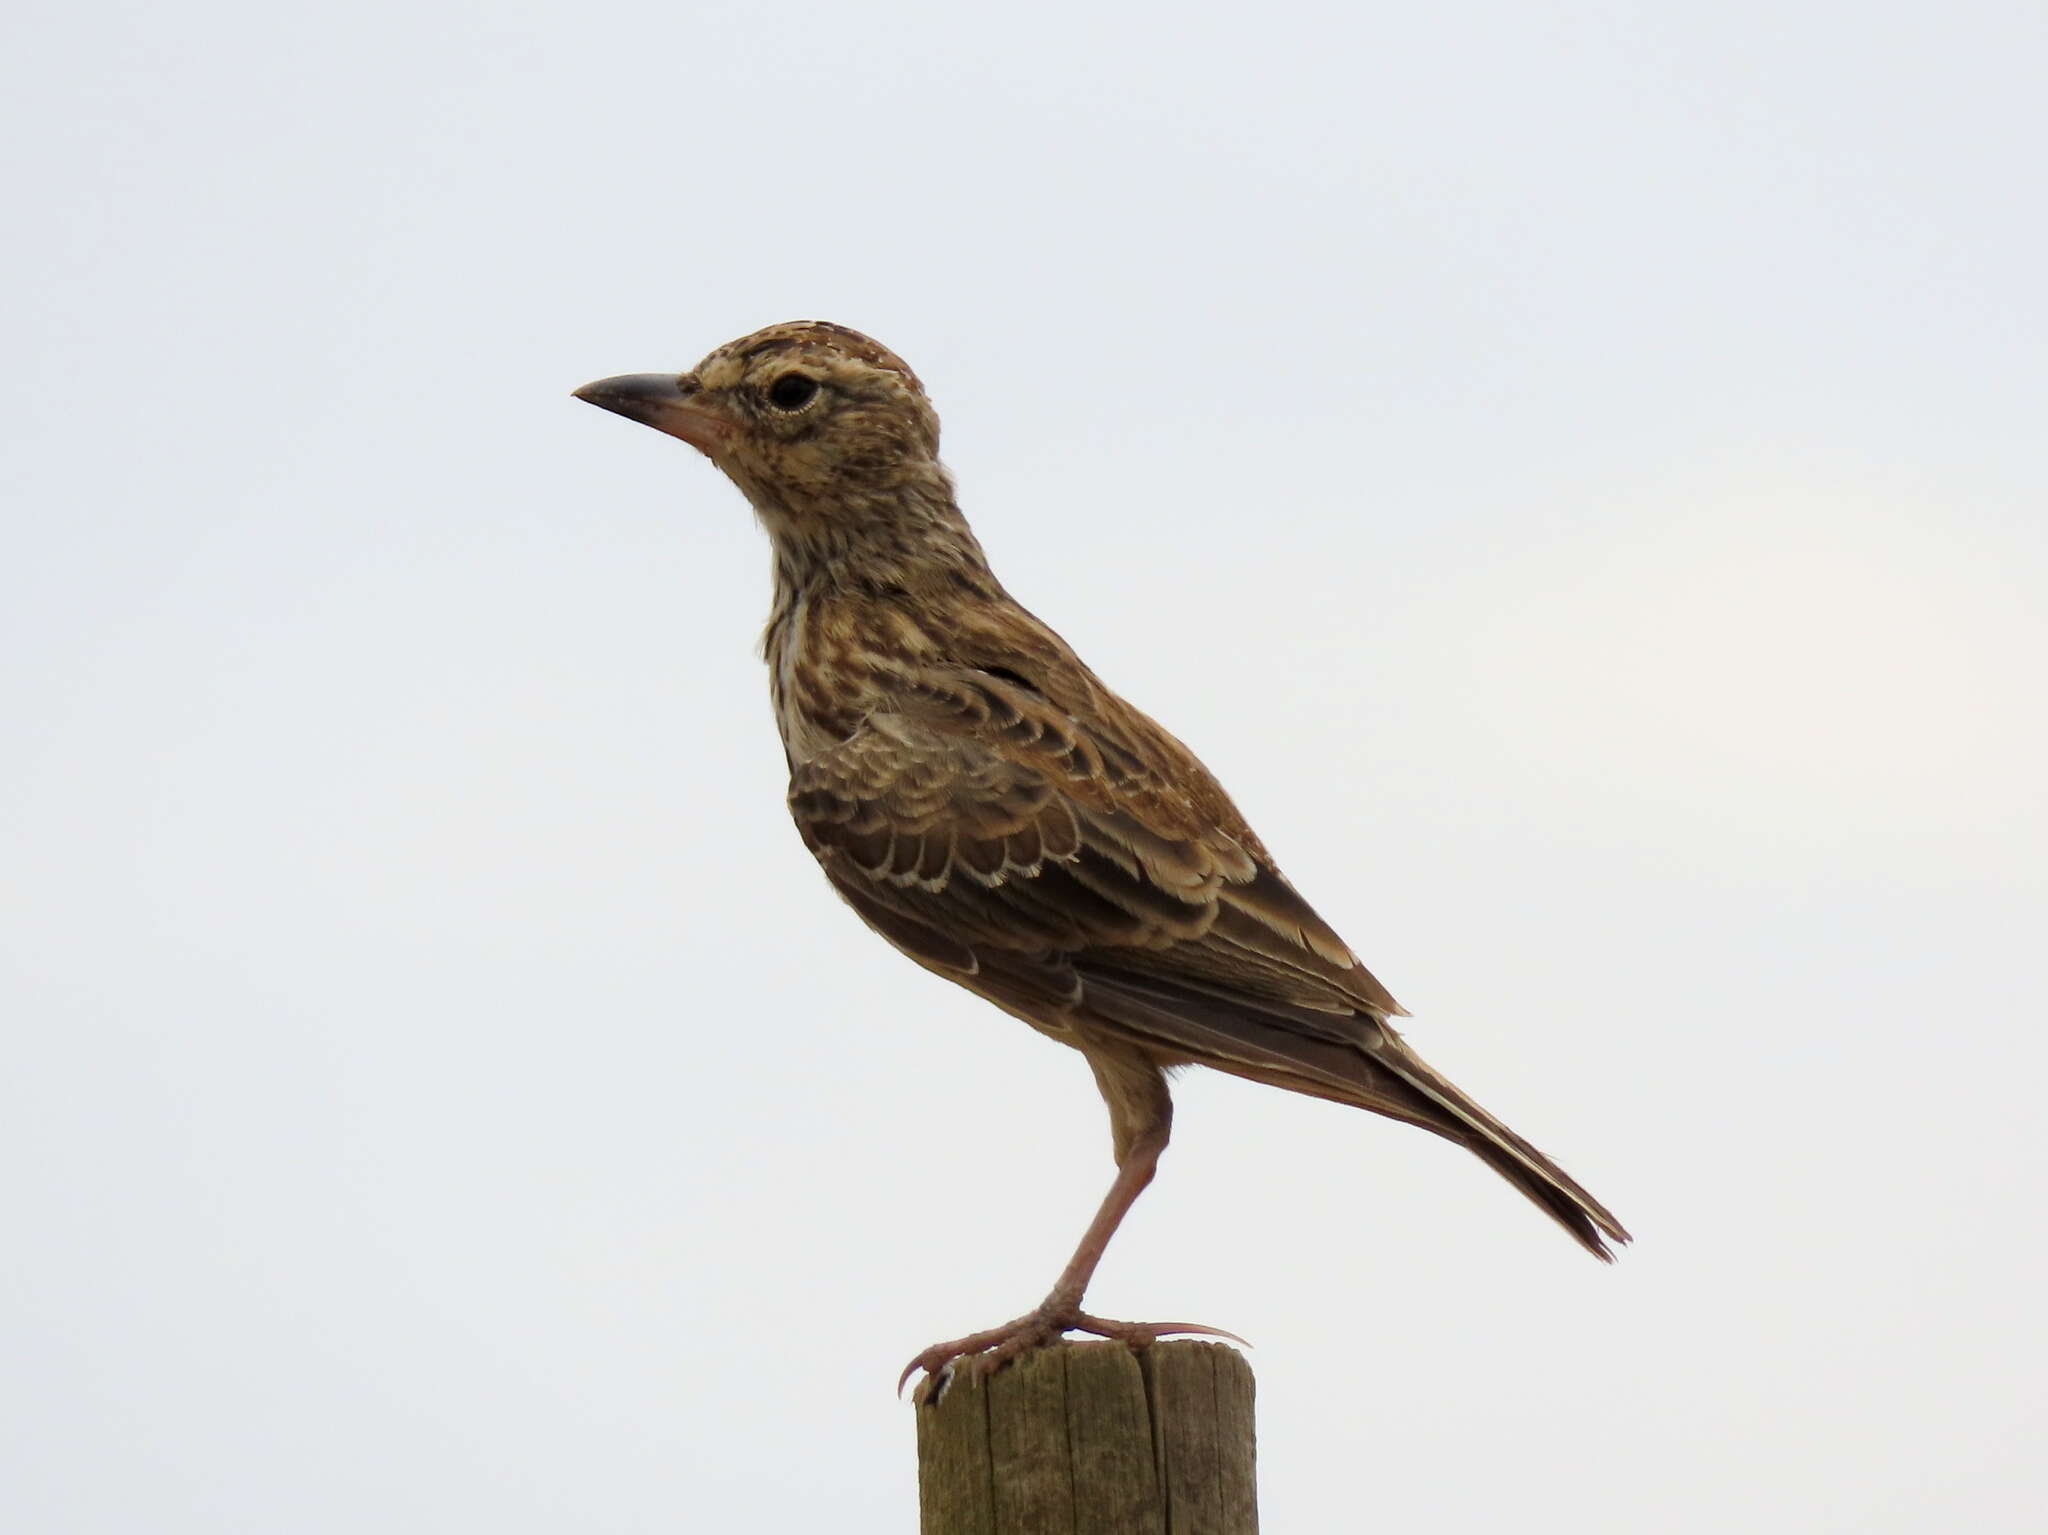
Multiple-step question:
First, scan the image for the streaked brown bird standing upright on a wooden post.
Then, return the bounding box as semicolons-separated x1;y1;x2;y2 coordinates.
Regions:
575;321;1628;1377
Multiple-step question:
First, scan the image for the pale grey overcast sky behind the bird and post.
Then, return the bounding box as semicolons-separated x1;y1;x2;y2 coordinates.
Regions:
0;0;2048;1535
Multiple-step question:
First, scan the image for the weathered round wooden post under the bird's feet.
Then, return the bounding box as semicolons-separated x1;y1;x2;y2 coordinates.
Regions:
915;1339;1260;1535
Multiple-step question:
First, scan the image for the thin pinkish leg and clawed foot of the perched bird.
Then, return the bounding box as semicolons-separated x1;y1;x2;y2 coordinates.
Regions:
897;1066;1243;1392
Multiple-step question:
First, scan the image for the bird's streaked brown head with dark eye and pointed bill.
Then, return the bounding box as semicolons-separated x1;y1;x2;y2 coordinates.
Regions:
575;319;952;564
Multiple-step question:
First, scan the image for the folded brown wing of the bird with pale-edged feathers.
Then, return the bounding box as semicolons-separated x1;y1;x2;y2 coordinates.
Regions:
788;669;1403;1044
